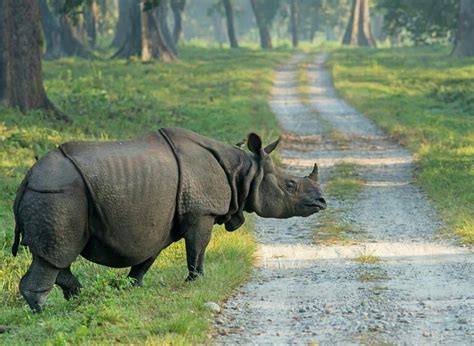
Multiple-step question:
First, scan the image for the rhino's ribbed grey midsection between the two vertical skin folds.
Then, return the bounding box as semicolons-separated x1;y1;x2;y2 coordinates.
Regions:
61;135;178;266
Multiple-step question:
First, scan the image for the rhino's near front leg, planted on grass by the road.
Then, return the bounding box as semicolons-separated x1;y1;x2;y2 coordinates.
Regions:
183;215;214;281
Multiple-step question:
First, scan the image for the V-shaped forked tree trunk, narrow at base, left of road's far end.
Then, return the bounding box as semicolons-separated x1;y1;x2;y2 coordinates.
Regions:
250;0;280;48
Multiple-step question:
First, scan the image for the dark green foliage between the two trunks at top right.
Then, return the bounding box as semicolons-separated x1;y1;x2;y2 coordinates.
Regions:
377;0;459;44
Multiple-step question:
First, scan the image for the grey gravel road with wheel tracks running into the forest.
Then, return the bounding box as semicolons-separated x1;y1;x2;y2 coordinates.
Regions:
214;54;474;345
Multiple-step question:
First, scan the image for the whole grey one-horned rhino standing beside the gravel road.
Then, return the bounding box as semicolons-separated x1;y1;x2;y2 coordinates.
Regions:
12;128;326;312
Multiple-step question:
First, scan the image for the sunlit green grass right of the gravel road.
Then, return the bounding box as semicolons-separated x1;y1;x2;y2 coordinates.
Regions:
330;47;474;244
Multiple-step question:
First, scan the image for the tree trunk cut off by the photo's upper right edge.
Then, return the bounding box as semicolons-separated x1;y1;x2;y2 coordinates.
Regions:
454;0;474;56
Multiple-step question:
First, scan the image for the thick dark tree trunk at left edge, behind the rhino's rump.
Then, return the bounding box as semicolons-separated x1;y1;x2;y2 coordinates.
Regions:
0;0;68;120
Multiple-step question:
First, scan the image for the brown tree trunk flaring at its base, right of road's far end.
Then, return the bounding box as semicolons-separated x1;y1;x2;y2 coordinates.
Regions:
342;0;376;47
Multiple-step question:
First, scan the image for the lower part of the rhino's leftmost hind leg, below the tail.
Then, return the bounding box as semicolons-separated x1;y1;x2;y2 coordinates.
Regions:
20;255;59;312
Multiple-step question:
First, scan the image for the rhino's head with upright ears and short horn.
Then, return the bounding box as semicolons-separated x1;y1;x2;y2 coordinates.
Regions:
247;133;326;218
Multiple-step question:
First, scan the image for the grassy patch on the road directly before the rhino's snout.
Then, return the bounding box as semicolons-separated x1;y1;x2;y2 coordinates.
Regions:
313;162;364;245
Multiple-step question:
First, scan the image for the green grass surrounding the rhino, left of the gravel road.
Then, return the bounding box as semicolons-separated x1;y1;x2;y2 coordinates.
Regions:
0;47;290;345
